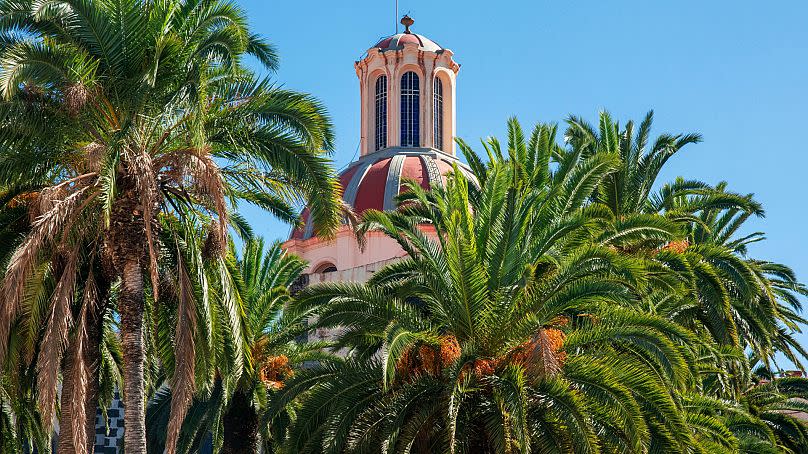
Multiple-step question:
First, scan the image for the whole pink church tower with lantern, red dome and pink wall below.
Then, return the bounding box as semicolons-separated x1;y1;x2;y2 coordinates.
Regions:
284;16;473;282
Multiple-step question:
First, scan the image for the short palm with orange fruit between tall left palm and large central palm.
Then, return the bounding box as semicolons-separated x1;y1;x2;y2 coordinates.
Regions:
147;238;334;453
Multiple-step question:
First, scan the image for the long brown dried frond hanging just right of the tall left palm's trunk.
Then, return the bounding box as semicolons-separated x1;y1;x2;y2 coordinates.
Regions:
166;255;196;454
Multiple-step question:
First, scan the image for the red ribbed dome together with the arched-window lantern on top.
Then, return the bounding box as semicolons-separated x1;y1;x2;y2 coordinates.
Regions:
290;16;475;241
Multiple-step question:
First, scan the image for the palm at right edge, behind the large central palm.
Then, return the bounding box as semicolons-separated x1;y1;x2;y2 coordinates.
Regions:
565;112;805;380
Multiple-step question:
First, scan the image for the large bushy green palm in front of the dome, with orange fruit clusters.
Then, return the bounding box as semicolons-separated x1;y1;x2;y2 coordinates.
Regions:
280;122;700;452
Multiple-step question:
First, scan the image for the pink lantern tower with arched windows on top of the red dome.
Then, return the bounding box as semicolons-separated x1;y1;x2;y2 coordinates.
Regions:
354;15;460;156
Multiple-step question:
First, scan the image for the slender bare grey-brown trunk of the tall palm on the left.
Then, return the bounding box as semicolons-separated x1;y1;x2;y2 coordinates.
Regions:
120;260;146;454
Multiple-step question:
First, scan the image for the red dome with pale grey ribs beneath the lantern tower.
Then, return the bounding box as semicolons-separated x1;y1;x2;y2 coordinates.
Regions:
290;148;476;240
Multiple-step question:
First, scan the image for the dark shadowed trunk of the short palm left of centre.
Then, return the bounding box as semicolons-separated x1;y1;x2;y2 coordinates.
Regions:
222;391;258;454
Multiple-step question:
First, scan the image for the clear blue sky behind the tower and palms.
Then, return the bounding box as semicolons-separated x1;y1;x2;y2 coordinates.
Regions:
239;0;808;362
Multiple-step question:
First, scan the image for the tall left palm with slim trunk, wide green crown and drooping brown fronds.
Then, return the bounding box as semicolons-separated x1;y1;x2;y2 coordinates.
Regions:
0;0;340;454
